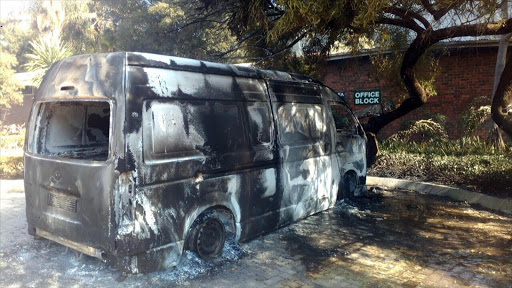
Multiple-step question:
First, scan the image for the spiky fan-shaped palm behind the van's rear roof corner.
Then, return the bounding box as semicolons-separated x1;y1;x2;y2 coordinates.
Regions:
24;35;73;87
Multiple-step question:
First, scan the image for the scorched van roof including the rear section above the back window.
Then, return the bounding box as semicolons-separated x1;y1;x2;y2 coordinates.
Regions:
35;52;322;101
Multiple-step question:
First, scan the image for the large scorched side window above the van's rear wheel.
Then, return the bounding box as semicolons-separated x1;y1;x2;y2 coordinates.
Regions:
143;101;245;159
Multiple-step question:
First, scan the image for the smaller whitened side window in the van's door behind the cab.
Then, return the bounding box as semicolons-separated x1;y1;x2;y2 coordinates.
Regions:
277;103;326;145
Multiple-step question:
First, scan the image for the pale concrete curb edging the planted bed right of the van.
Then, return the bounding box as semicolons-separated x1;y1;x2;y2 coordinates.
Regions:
366;176;512;214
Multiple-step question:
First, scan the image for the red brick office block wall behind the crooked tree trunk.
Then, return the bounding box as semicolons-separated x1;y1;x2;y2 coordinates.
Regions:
324;48;497;139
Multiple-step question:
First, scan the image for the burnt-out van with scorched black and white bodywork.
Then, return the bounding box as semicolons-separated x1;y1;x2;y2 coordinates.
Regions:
24;52;366;273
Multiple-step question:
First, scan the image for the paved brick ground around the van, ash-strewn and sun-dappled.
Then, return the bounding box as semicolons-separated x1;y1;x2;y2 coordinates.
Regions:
0;181;512;288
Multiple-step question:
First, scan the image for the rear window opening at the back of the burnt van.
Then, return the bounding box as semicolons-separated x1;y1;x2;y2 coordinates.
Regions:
34;101;111;161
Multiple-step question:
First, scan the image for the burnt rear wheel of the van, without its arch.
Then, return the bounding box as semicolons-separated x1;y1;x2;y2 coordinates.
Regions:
192;215;226;260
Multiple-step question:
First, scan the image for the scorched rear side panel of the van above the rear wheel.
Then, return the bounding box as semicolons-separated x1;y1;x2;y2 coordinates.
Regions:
126;67;278;247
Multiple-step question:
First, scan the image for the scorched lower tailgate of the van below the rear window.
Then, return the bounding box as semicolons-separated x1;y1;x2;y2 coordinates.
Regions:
25;153;115;249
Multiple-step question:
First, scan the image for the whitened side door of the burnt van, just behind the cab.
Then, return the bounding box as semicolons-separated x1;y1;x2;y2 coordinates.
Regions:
268;81;332;224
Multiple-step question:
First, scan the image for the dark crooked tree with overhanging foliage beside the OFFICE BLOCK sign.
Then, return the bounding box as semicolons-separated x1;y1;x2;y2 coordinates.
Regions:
195;0;512;162
